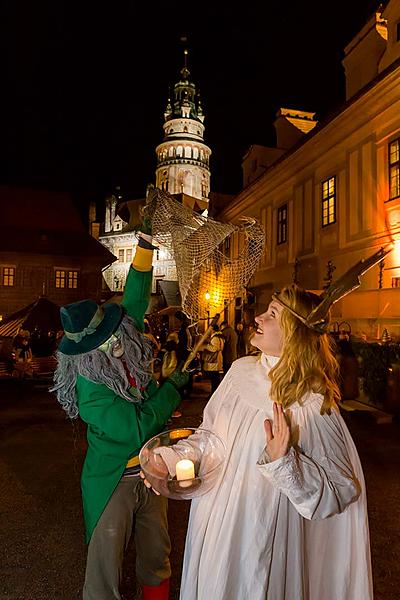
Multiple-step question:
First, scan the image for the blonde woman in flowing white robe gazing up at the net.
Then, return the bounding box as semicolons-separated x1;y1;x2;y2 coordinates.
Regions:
146;285;373;600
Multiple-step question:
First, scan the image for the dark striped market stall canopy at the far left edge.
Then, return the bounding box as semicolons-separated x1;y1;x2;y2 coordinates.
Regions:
0;296;62;337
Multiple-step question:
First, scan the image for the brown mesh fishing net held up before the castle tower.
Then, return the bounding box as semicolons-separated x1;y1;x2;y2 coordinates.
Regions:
143;188;265;320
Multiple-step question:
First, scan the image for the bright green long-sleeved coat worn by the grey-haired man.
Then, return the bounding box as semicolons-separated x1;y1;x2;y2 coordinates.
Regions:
76;268;181;542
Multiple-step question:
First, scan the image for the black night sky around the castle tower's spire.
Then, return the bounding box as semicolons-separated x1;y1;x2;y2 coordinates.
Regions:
0;0;379;218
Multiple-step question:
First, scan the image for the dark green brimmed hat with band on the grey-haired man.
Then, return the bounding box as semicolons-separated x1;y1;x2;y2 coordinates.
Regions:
58;300;124;355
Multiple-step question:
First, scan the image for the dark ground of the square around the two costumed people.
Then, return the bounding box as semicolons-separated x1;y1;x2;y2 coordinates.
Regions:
0;381;400;600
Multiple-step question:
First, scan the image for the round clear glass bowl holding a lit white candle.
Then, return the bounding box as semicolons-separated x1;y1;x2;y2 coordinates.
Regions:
139;427;225;500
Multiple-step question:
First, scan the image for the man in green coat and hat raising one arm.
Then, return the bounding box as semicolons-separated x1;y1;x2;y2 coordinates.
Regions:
53;233;188;600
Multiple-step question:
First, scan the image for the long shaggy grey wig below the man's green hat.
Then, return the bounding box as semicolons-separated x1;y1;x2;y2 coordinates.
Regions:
50;315;153;419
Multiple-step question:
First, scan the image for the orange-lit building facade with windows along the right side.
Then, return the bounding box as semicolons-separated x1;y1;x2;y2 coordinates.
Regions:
218;0;400;340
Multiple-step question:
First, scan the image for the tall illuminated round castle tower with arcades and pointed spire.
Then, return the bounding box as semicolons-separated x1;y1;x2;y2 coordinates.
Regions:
156;50;211;205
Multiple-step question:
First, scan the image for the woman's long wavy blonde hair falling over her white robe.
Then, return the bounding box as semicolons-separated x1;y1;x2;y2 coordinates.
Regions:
269;284;340;414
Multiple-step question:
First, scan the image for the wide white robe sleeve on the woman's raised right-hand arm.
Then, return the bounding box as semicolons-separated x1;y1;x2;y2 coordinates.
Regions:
257;402;361;520
